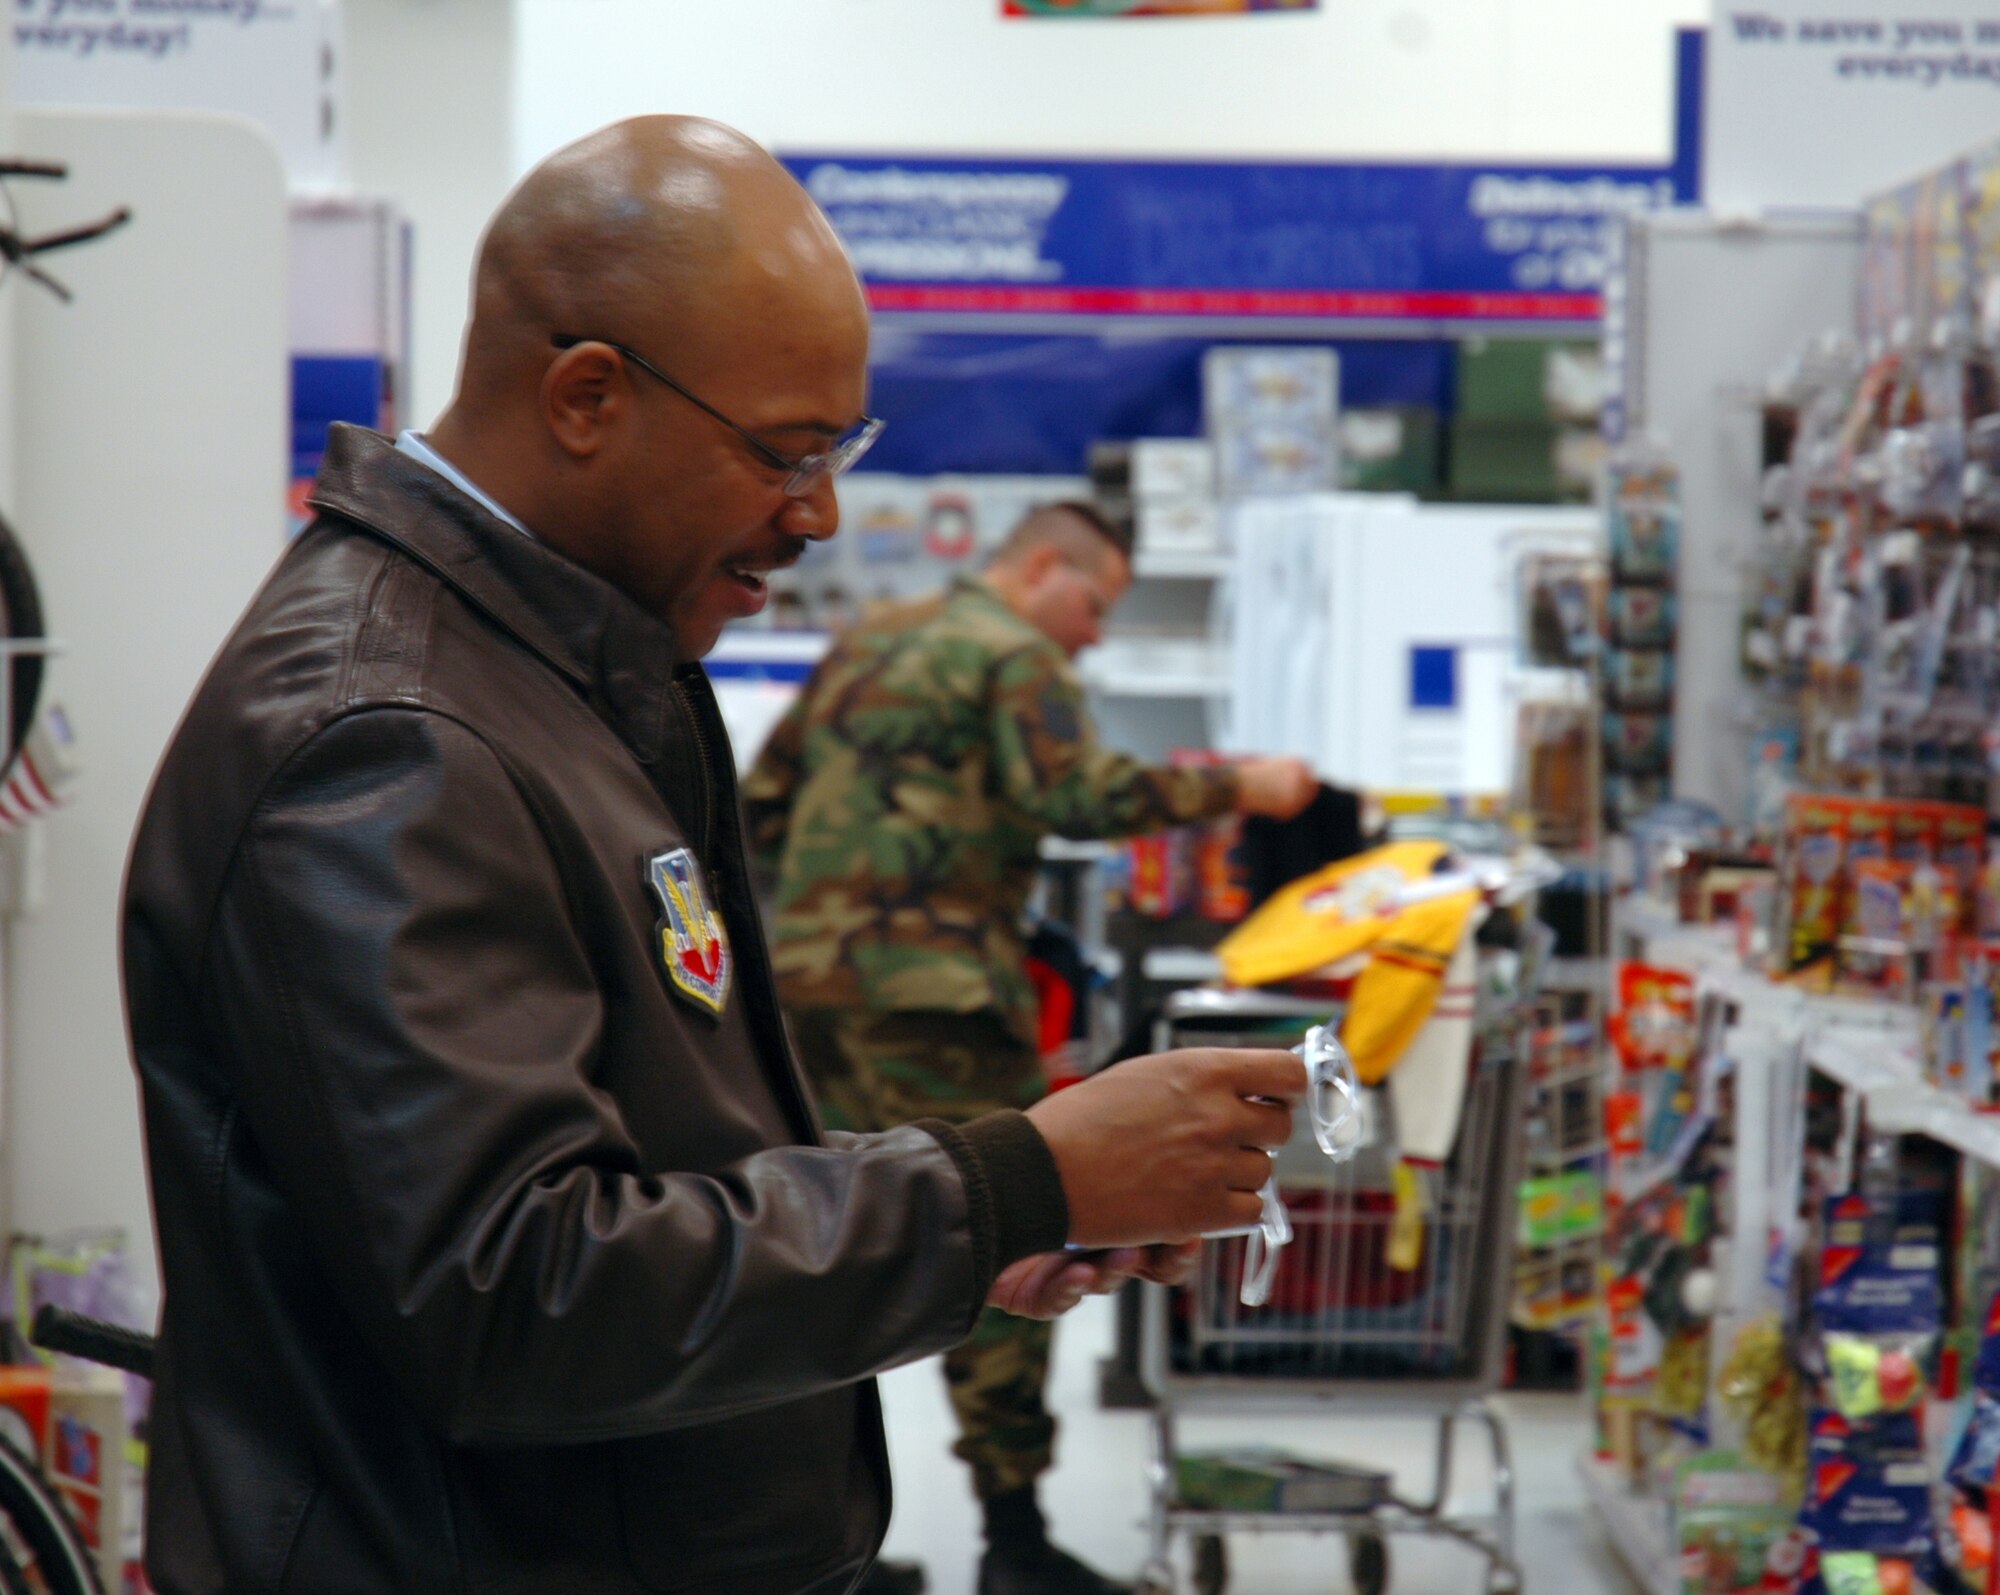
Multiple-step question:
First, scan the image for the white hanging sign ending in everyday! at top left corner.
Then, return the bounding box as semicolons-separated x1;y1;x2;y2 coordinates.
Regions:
12;0;344;190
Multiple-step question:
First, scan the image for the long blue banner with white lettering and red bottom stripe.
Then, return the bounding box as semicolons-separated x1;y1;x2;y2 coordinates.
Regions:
786;34;1700;324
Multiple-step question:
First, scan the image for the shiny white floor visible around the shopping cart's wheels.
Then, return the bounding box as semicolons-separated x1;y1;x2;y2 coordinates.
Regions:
882;1301;1636;1595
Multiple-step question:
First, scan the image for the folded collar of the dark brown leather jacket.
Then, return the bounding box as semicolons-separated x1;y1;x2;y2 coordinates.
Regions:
308;424;684;764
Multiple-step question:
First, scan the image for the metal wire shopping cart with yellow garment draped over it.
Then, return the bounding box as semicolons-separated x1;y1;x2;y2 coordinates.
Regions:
1140;989;1522;1595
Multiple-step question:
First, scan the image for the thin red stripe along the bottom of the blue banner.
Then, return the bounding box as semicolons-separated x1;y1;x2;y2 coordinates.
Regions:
868;282;1604;322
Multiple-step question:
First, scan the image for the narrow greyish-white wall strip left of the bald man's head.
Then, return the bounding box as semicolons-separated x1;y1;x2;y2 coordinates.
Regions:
346;0;514;426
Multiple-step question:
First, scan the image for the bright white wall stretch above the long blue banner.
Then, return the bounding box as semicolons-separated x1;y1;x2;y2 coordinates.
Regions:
514;0;1708;166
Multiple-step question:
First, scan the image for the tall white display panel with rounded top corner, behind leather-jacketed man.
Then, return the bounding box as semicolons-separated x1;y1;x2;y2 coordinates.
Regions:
0;112;288;1311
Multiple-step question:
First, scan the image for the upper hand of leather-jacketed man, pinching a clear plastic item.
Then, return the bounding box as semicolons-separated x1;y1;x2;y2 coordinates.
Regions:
1028;1047;1306;1247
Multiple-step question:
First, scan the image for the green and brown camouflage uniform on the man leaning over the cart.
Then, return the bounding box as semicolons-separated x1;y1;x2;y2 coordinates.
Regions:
744;580;1236;1499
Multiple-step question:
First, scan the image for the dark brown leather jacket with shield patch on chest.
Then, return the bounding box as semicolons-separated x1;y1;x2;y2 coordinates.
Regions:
124;428;1068;1595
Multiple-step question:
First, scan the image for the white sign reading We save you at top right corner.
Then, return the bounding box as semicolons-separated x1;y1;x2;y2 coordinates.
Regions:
1702;0;2000;212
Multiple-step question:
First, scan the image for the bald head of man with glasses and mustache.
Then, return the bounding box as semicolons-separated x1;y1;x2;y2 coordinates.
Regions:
430;116;868;658
